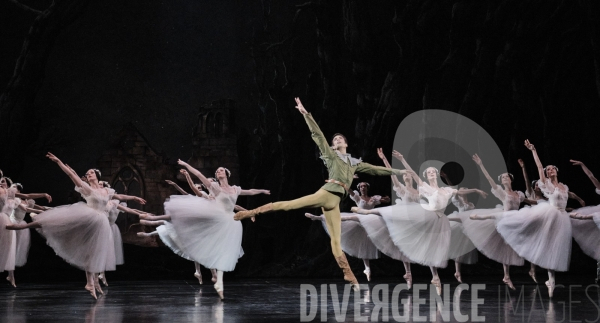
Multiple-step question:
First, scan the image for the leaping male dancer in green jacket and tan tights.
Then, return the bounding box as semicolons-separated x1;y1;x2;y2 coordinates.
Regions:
234;98;405;290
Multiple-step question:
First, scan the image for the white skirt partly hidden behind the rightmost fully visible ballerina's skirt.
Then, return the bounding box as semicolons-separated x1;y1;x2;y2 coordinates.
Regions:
458;208;525;266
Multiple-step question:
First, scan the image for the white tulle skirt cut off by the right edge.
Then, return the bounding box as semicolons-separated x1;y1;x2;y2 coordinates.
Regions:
571;205;600;261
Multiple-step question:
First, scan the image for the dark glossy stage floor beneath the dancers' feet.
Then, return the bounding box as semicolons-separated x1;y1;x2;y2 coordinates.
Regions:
0;274;600;323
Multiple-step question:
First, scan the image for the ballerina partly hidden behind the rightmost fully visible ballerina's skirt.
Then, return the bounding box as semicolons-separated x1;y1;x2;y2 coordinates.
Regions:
459;154;524;290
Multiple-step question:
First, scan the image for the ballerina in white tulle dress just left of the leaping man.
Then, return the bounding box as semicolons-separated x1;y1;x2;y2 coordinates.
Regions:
142;160;270;299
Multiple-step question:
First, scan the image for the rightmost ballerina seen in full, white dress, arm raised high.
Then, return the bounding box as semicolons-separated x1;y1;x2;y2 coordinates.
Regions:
478;140;572;297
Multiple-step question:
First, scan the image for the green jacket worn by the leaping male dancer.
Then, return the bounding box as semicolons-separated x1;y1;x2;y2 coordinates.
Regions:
304;113;402;197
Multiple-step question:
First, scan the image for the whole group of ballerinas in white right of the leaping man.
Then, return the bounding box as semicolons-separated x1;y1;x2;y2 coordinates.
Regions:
306;141;600;297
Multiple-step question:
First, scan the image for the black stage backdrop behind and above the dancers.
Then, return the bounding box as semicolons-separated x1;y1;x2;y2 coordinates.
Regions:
0;0;600;280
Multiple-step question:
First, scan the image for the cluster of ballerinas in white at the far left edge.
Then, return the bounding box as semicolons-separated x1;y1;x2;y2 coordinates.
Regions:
0;153;146;298
